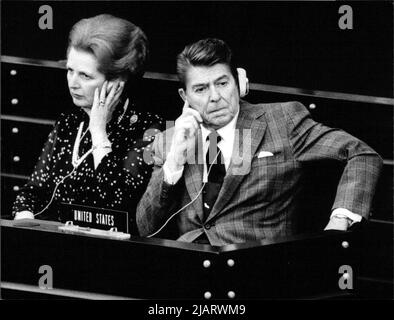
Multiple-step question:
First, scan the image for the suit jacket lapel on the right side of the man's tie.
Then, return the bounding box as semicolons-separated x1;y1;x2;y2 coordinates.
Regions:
207;102;267;220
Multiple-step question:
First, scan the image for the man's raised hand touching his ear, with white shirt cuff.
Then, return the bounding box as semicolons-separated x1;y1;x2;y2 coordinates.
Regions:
166;101;202;172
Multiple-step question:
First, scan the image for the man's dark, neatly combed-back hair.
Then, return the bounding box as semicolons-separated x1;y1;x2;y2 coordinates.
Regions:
177;38;238;89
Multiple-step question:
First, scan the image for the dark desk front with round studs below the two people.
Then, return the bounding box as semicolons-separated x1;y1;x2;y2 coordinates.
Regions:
1;220;357;299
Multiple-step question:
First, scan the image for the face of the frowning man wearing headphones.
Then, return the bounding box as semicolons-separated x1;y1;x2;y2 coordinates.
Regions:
180;63;239;130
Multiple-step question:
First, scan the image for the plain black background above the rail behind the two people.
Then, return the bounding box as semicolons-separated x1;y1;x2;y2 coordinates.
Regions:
1;1;393;97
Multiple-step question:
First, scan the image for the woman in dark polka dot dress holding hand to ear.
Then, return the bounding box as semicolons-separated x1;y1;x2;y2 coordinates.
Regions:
13;15;163;230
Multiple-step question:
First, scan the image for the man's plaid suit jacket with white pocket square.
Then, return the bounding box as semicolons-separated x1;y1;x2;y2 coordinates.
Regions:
136;101;382;246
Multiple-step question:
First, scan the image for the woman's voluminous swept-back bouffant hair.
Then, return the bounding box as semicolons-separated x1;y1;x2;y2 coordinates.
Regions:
67;14;148;80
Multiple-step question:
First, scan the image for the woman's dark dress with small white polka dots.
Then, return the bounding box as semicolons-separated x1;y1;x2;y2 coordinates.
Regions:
13;99;164;229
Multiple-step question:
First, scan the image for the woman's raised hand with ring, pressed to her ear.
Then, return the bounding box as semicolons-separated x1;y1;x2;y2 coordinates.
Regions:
89;81;124;145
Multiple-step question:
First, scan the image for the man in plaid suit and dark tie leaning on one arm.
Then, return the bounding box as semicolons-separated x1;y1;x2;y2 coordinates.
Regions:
137;39;382;246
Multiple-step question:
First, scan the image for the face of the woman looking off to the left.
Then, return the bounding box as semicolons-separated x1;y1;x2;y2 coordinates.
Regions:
67;47;106;109
